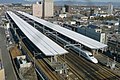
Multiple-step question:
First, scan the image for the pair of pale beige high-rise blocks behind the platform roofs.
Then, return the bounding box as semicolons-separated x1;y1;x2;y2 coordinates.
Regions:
33;0;54;18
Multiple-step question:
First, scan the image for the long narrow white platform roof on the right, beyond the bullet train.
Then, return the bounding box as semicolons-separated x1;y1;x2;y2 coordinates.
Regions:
17;11;107;49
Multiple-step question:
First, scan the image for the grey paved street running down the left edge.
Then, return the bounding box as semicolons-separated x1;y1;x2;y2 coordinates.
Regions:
0;27;17;80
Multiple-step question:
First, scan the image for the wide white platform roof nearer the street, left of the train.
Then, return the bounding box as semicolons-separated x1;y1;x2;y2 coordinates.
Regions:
7;11;68;56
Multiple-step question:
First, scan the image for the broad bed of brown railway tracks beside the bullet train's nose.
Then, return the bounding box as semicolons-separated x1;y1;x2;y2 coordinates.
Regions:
37;30;120;80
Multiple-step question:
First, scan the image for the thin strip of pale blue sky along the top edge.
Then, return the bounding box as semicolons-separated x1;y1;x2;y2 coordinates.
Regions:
0;0;120;3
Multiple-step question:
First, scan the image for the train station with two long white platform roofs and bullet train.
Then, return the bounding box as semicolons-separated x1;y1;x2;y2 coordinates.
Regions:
6;11;120;79
